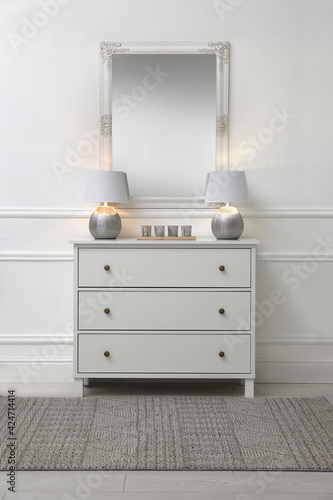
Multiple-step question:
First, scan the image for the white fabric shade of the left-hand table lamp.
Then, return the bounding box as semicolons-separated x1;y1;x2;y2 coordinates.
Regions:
84;170;129;203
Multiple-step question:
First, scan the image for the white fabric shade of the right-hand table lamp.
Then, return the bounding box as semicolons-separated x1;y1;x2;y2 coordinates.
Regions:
205;170;249;203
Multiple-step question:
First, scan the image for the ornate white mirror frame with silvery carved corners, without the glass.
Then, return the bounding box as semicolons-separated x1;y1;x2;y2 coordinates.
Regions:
100;41;229;208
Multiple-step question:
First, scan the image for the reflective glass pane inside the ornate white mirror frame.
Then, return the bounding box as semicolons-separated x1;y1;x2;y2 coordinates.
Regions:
112;54;216;197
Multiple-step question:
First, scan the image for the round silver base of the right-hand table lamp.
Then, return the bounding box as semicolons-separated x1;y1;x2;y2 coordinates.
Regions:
212;205;244;240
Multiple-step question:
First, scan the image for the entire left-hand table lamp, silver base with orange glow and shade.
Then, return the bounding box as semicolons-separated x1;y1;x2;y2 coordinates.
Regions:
84;170;129;239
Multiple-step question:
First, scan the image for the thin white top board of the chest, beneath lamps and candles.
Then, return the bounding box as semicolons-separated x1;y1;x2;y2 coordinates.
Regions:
70;238;260;248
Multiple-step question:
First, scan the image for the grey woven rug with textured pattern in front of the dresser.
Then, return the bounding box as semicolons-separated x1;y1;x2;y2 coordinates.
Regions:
0;396;333;471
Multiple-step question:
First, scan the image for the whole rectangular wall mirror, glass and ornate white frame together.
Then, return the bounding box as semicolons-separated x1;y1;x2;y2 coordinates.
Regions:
100;42;229;207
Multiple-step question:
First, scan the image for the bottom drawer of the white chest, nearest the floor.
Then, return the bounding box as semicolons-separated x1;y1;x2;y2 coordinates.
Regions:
78;333;251;374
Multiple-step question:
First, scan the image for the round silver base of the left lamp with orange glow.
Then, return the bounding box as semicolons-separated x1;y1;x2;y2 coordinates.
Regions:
89;205;121;240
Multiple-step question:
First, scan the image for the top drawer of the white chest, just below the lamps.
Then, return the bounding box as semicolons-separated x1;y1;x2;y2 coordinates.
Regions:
78;248;251;288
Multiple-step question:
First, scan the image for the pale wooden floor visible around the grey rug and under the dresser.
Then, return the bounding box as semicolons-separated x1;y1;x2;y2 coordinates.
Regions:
0;382;333;500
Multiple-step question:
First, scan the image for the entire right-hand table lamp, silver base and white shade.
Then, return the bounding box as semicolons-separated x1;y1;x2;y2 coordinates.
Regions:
205;170;249;240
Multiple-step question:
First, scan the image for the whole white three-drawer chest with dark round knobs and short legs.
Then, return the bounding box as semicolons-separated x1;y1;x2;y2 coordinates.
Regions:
74;239;258;397
